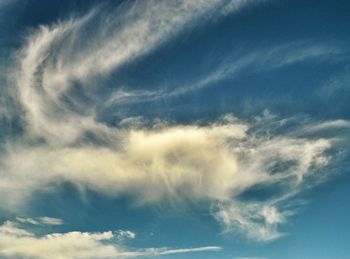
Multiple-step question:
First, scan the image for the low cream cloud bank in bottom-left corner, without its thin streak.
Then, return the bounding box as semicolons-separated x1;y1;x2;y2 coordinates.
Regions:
0;222;119;258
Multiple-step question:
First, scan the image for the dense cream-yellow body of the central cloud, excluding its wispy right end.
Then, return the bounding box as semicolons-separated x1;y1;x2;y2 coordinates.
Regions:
3;118;249;203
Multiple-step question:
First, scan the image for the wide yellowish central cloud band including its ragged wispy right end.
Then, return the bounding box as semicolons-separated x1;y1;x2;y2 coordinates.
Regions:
1;115;344;241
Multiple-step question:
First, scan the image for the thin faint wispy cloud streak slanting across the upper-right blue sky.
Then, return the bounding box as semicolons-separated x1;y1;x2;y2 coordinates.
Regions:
158;41;347;101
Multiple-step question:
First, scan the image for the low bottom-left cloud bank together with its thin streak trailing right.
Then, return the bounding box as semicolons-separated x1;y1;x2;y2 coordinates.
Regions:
0;221;221;259
